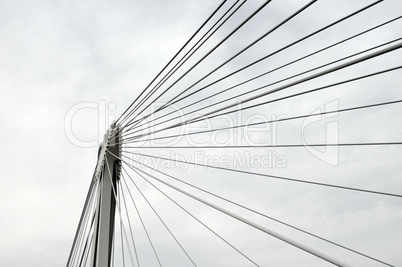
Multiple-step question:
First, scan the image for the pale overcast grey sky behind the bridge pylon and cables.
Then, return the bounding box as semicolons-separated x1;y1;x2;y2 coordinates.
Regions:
0;0;402;267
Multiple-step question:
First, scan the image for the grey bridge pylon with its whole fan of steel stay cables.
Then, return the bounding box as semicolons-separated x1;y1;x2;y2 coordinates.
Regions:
67;0;402;266
